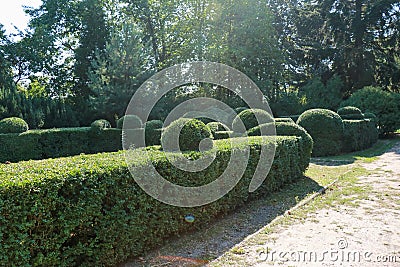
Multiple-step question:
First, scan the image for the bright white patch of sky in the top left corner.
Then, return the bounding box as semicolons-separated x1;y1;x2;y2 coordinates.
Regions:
0;0;42;34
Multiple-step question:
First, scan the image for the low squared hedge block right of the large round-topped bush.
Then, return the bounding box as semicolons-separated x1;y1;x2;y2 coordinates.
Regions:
343;119;379;152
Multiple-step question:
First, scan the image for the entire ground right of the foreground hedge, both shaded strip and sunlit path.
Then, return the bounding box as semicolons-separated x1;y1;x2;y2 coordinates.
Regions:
123;137;400;267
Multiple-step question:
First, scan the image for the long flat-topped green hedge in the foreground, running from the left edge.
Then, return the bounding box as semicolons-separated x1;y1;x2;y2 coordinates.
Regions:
0;135;305;266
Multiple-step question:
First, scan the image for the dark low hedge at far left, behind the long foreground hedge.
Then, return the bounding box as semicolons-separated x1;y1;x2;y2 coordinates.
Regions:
0;127;122;162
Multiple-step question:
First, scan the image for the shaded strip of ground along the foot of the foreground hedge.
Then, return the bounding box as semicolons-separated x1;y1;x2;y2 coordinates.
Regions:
120;177;322;267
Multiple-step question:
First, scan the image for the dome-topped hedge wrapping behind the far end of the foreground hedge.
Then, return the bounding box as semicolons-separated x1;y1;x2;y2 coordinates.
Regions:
247;122;314;171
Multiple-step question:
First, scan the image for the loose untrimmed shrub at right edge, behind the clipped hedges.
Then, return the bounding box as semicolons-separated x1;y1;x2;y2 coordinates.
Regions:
342;86;400;135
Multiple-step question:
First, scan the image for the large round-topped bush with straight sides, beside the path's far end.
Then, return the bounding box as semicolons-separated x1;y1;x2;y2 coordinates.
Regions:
297;109;343;157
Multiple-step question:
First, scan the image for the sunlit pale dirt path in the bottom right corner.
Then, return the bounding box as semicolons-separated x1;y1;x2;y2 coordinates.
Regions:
210;144;400;267
